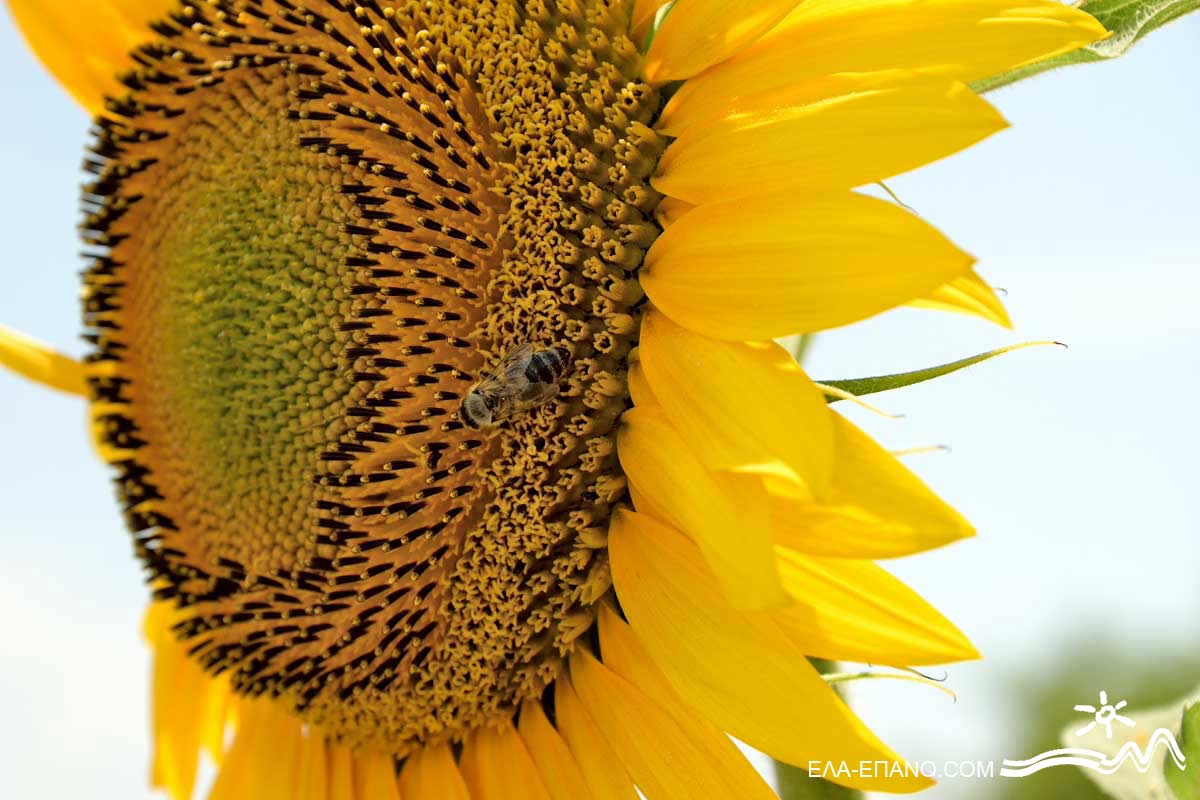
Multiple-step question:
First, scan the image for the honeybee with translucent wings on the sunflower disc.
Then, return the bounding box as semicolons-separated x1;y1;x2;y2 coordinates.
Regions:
458;344;571;429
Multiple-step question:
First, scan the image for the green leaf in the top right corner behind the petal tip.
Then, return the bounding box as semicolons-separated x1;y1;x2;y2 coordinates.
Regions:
971;0;1200;92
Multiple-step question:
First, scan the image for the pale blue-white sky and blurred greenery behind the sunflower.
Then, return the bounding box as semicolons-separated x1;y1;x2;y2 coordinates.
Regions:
0;7;1200;800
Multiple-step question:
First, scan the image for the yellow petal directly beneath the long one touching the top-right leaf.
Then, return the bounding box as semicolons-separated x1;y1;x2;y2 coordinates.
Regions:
653;77;1007;204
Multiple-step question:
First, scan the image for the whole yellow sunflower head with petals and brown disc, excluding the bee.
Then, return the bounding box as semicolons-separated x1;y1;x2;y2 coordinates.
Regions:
0;0;1104;800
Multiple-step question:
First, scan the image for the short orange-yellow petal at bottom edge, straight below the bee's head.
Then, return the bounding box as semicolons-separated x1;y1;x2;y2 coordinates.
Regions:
458;720;550;800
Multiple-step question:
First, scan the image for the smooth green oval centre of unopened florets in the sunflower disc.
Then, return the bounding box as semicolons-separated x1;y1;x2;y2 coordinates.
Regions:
126;67;361;572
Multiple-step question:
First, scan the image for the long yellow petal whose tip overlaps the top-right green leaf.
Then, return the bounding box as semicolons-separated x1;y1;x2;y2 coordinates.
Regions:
660;0;1105;131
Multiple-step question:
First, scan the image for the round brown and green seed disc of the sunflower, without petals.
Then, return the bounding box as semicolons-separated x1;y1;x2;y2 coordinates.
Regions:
84;0;664;754
